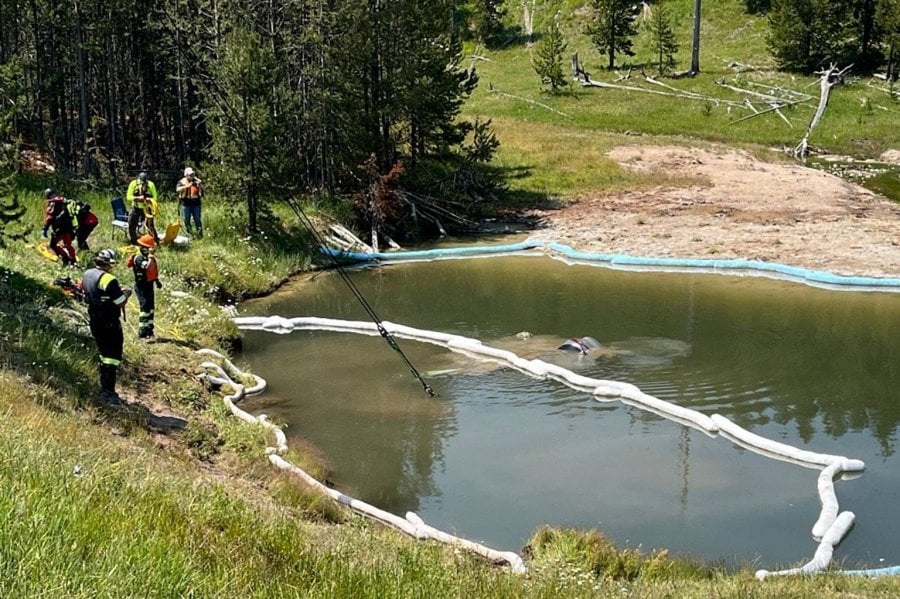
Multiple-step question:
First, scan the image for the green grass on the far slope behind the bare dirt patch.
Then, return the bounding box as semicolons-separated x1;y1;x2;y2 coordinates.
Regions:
464;0;900;202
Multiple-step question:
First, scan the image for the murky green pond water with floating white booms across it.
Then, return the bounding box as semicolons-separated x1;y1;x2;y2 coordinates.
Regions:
242;256;900;567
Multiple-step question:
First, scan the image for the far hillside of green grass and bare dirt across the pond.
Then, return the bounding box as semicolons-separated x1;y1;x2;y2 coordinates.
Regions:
466;0;900;277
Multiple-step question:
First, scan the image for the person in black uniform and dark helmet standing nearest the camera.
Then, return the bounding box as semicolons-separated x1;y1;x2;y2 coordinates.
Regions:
81;249;131;406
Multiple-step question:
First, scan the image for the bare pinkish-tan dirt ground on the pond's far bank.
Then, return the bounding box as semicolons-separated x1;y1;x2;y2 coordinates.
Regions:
537;146;900;277
